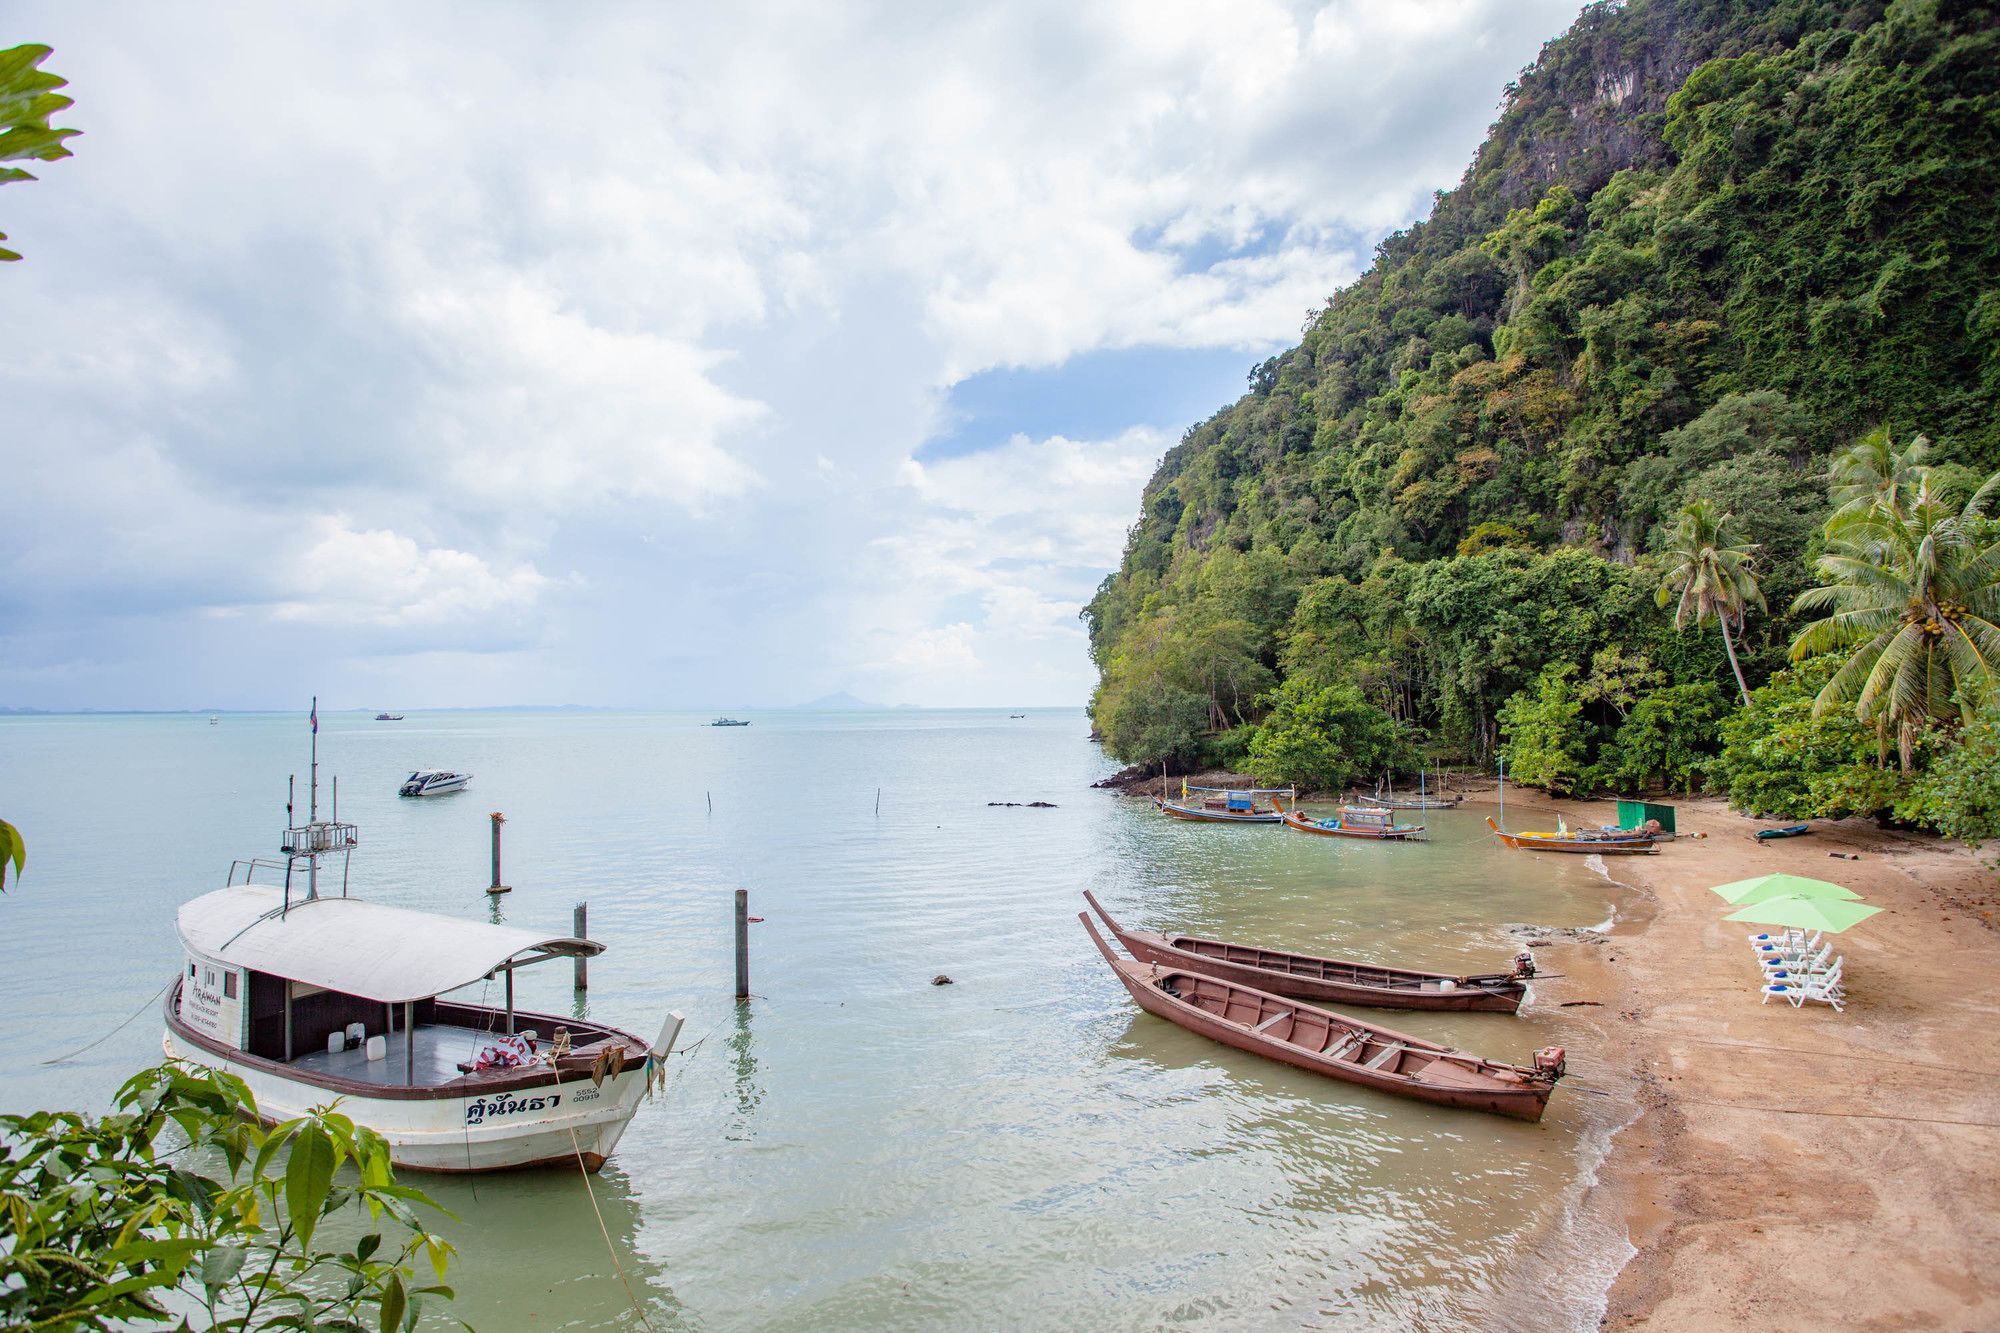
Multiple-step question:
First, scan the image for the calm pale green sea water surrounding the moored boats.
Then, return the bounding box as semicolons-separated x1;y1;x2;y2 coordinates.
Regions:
0;711;1616;1329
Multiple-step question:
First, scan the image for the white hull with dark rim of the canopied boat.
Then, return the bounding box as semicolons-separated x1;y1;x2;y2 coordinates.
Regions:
160;987;656;1175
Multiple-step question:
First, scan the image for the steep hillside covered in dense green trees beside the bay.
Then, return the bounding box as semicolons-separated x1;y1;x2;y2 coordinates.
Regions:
1084;0;2000;829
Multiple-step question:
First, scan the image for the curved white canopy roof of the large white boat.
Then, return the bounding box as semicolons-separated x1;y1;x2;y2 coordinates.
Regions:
176;885;604;1005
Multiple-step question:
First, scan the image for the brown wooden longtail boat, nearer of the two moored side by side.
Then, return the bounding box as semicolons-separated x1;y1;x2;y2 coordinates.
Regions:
1076;913;1564;1121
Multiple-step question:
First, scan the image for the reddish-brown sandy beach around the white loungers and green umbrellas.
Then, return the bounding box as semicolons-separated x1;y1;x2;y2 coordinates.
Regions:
1476;791;2000;1329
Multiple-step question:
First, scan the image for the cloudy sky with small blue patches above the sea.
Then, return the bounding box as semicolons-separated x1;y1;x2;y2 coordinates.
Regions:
0;0;1576;709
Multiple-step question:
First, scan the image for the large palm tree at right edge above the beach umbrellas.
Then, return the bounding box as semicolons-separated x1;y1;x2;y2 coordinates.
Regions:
1792;472;2000;769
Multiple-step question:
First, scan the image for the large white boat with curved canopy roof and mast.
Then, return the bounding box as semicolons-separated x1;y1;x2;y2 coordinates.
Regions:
162;700;682;1171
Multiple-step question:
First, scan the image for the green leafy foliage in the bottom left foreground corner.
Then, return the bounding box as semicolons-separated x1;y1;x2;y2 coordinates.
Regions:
0;1063;452;1333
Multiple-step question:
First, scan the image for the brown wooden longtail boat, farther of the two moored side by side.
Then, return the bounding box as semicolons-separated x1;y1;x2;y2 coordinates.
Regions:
1084;889;1534;1013
